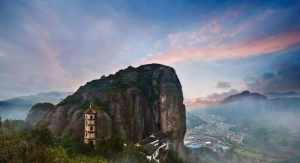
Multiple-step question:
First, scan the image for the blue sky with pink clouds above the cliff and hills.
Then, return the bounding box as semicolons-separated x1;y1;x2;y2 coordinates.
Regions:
0;0;300;99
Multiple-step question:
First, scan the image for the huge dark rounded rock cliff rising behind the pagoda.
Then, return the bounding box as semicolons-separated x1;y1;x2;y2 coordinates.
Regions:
27;64;186;151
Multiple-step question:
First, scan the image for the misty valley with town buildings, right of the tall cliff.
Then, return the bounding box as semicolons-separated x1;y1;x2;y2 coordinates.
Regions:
184;93;300;163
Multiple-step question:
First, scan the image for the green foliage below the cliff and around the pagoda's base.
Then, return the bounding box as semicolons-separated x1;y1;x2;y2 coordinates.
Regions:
0;121;178;163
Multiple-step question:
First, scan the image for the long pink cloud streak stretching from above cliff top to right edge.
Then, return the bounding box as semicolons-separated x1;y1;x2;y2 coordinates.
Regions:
146;31;300;64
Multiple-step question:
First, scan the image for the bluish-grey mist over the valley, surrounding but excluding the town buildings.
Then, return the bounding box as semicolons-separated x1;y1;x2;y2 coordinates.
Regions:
188;97;300;163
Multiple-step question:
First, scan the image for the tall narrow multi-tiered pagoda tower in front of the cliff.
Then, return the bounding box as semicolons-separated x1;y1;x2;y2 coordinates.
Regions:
84;104;97;145
